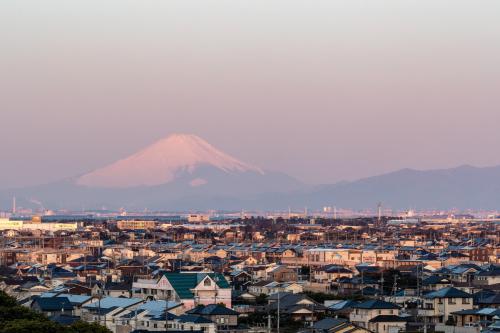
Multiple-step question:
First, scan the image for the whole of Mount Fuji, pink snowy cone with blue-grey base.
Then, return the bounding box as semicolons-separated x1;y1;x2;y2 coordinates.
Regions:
0;134;305;210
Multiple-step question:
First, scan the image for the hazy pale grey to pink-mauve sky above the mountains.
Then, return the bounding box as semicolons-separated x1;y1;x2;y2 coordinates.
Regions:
0;0;500;187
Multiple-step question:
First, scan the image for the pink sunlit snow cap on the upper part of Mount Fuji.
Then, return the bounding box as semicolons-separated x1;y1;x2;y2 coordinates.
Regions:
76;134;264;188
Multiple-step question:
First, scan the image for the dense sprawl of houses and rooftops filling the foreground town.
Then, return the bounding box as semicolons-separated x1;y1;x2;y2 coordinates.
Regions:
0;217;500;333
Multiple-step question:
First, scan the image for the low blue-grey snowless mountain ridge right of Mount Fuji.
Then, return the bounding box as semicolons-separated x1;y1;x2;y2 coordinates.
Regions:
297;166;500;209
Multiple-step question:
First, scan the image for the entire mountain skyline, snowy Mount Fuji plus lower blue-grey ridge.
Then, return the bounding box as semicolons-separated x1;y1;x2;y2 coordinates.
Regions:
0;134;500;210
